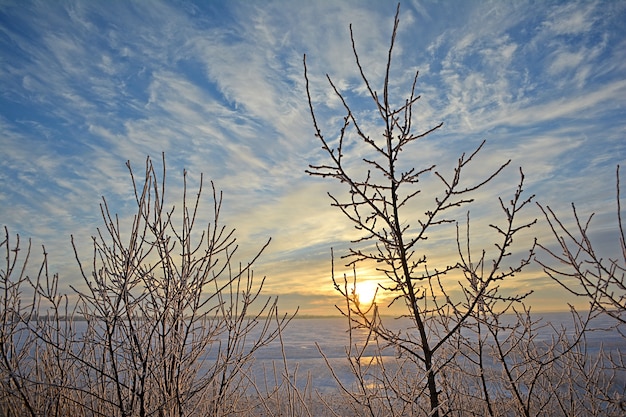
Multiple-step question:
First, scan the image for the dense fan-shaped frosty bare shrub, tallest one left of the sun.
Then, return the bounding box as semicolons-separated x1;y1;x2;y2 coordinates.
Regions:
68;154;288;416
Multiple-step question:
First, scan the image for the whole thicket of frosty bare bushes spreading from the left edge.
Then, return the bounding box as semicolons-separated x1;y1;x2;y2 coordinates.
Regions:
0;154;292;416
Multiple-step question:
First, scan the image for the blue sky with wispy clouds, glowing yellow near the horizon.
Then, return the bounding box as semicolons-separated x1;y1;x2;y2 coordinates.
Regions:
0;0;626;315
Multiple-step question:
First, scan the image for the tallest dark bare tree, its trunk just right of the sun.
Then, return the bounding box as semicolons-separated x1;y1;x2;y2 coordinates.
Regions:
304;6;535;416
